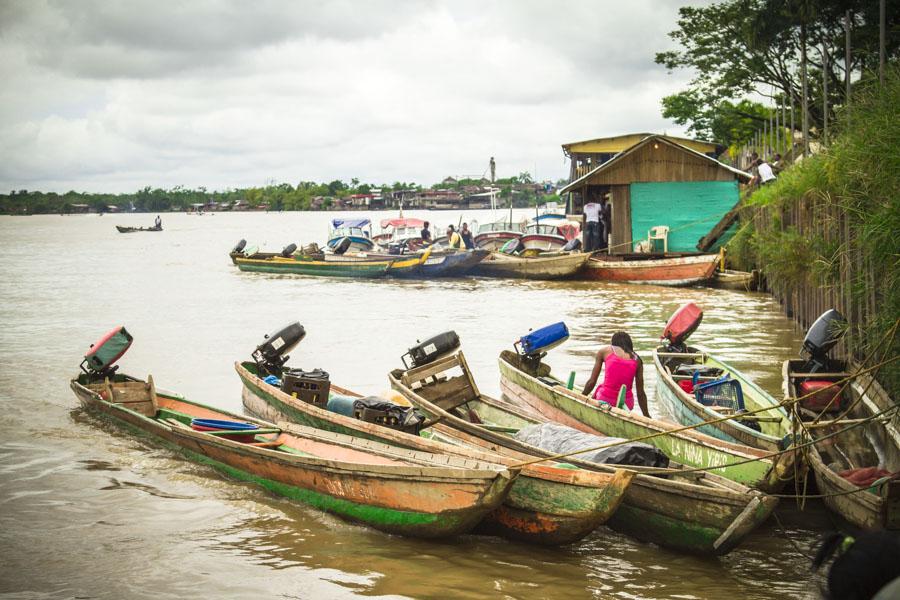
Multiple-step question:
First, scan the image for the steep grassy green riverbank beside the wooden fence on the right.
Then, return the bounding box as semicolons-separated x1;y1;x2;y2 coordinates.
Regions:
728;68;900;396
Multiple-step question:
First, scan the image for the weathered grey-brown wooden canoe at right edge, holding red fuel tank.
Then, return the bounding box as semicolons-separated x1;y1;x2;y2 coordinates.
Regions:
782;360;900;530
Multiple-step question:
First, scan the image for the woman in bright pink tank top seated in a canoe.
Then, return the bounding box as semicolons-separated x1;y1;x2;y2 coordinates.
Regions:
581;331;650;417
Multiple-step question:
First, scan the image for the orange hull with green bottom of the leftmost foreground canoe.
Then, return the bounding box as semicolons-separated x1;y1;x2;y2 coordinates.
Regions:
72;380;511;538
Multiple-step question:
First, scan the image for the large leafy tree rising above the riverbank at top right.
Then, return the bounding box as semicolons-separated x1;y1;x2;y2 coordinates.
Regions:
656;0;900;142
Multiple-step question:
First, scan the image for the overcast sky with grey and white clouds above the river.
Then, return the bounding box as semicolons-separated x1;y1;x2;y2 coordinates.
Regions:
0;0;690;192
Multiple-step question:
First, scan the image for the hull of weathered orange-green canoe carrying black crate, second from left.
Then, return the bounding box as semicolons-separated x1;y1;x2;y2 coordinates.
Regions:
234;362;634;545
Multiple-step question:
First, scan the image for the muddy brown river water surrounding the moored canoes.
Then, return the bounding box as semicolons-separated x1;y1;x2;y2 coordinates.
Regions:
0;211;831;599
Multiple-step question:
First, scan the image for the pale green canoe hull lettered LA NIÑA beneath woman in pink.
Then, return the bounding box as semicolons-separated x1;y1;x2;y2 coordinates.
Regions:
499;350;793;493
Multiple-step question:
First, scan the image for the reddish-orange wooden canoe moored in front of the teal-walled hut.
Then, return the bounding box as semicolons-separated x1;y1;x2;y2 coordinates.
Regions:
582;254;719;286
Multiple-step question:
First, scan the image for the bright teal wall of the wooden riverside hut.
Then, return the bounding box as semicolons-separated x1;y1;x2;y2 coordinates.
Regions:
631;181;739;252
